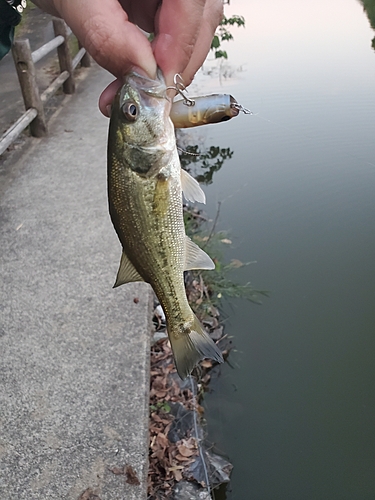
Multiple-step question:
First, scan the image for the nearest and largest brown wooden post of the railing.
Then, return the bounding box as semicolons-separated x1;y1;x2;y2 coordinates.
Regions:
12;40;47;137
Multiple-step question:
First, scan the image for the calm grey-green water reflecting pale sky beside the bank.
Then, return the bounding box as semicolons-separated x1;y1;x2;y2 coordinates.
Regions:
184;0;375;500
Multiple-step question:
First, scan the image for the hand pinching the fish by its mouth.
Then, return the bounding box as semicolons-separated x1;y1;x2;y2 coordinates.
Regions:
34;0;223;116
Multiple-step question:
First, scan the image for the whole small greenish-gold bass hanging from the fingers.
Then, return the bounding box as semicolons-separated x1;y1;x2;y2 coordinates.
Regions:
108;70;223;379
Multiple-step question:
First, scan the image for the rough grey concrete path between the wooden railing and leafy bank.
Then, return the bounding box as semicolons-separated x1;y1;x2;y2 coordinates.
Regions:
0;67;152;500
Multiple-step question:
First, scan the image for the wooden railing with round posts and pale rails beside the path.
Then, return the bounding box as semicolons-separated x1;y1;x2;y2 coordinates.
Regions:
0;18;90;155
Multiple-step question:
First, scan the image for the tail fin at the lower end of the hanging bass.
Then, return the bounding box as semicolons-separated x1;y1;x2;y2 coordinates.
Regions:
169;316;224;379
